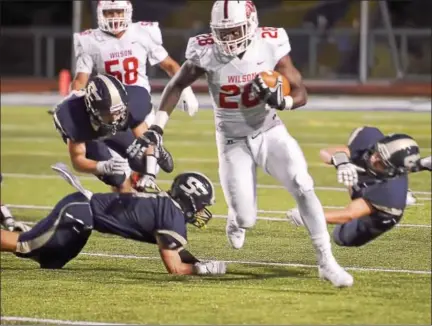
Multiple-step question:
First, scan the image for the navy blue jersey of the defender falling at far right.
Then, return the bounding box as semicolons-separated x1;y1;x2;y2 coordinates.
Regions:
348;127;408;218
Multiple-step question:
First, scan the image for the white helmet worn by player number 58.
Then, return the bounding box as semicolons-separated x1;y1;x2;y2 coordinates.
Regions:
97;0;132;35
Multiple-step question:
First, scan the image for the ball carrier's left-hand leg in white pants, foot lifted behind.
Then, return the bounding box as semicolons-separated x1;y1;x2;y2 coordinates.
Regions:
217;135;257;249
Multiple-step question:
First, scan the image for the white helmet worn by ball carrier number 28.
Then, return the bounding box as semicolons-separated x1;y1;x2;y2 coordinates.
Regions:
210;0;258;56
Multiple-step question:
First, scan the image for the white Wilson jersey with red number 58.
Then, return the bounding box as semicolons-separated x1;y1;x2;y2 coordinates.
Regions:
74;22;168;92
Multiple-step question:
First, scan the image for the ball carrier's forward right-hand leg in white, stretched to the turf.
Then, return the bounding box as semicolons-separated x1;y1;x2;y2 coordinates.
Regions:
264;126;353;287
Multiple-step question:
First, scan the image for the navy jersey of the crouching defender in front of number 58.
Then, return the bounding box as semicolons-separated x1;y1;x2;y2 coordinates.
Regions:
53;86;152;143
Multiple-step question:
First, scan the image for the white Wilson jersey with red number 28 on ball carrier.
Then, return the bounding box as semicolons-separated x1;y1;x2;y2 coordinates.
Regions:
186;27;291;137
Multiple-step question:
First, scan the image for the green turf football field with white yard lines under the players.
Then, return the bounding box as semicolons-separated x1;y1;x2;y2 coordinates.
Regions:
1;107;431;324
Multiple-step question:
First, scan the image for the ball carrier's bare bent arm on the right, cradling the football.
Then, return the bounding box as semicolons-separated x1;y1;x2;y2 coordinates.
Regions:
275;54;307;110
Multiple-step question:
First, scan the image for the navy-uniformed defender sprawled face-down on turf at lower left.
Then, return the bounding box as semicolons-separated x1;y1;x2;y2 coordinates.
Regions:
1;164;226;275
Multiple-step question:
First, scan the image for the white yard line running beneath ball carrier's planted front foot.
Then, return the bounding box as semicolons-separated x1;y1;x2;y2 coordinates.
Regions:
80;252;431;275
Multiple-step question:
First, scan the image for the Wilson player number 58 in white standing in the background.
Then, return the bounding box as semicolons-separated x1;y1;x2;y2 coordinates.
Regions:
72;0;198;115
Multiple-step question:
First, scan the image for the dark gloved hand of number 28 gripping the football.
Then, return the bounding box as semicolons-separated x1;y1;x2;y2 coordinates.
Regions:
252;74;286;110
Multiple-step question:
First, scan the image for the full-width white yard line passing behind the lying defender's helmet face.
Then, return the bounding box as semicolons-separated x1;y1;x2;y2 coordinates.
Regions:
2;173;432;196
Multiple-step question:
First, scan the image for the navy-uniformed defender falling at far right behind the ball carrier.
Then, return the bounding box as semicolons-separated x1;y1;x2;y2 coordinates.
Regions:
287;127;431;246
